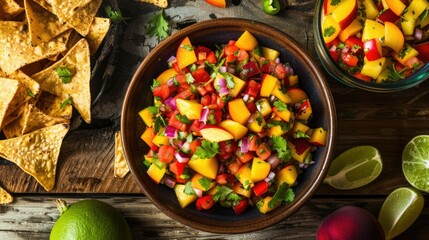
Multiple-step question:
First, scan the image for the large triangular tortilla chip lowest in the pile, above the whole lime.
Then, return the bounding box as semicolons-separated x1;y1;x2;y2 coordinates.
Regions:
0;124;69;191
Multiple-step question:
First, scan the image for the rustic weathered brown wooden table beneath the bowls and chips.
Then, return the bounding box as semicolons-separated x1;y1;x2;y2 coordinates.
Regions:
0;0;429;239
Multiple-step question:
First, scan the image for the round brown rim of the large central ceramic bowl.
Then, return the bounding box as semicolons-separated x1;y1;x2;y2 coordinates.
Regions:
121;18;337;234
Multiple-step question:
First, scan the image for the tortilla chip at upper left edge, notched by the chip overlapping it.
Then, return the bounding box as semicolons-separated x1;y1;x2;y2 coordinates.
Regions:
0;21;67;73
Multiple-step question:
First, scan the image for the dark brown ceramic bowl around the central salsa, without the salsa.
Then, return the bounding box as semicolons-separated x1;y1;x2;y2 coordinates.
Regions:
121;18;336;233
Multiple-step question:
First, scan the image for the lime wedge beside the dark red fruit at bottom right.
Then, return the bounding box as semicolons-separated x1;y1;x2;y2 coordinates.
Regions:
378;187;424;239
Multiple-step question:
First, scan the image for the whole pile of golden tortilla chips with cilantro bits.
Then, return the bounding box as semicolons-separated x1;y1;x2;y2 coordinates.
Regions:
0;0;110;191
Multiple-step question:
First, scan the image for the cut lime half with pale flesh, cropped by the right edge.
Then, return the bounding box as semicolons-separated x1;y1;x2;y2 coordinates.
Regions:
402;135;429;192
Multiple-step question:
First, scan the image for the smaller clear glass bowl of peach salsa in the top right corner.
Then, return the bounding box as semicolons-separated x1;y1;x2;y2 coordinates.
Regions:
314;0;429;92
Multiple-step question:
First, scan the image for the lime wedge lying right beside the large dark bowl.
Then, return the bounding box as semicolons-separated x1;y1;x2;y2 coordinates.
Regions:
323;146;383;190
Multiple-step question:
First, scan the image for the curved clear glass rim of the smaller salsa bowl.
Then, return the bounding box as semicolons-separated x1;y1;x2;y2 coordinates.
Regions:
313;0;429;93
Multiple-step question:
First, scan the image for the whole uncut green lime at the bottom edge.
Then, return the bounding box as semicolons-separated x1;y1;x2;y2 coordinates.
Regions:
50;200;132;240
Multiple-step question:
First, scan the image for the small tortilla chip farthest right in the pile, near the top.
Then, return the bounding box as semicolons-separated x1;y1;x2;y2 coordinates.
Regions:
85;17;110;56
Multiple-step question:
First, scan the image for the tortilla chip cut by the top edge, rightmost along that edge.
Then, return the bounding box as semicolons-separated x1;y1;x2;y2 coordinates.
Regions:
67;0;103;36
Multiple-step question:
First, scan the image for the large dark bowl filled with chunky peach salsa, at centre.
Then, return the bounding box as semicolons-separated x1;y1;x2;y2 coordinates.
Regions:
121;18;336;233
